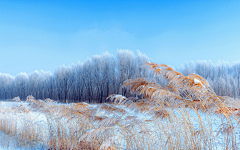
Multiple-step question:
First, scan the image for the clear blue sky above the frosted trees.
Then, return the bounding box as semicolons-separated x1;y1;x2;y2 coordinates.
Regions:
0;0;240;76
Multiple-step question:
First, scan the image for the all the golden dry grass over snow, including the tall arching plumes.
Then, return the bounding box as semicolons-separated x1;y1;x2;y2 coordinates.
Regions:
0;63;240;150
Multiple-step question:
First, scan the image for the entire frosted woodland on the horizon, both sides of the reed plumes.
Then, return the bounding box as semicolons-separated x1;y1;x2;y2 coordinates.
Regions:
0;50;240;103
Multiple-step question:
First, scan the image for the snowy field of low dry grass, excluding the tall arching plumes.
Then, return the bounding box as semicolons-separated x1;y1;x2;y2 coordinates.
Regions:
0;100;240;149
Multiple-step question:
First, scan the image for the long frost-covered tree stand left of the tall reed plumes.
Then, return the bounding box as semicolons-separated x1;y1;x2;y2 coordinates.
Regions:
0;50;149;103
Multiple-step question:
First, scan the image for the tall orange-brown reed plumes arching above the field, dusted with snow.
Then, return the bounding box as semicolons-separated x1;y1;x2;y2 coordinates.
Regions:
123;63;237;111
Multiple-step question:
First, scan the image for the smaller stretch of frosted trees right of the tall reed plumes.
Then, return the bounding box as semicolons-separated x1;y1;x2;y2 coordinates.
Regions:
179;60;240;98
